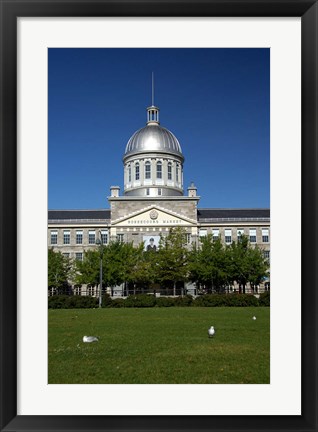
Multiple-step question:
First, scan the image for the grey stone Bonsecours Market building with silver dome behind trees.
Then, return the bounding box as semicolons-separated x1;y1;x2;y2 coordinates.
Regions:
48;105;270;295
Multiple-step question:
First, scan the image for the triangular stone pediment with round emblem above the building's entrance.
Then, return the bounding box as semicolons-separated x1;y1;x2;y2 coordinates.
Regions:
112;205;197;227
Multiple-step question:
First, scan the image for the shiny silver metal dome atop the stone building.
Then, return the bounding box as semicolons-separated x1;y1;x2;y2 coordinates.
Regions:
124;122;184;160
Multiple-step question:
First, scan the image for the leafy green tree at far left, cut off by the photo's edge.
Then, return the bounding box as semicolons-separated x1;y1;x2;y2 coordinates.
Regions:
48;248;72;292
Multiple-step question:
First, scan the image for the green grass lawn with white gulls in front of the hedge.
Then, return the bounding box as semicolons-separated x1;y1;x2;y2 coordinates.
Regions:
48;307;270;384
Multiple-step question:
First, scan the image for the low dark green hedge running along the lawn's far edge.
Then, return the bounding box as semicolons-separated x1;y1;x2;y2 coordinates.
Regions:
48;291;270;309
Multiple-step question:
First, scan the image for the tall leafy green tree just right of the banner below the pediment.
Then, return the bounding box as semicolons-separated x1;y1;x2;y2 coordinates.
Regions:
155;227;188;295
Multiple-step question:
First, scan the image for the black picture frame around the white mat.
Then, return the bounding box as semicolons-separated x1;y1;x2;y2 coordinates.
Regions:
0;0;318;432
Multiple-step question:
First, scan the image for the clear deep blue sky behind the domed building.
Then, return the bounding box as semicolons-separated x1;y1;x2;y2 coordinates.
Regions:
48;48;270;209
